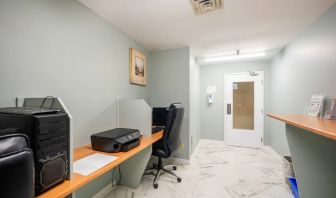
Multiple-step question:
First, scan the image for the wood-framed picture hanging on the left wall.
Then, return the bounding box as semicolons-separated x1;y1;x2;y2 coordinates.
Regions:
130;48;147;86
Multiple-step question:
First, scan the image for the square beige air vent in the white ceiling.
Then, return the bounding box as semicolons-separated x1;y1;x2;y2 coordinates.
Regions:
190;0;223;14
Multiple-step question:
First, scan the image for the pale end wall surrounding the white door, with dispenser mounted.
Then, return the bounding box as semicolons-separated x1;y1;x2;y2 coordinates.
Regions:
200;61;271;144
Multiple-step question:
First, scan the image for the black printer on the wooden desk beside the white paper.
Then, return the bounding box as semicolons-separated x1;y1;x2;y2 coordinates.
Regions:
91;128;140;153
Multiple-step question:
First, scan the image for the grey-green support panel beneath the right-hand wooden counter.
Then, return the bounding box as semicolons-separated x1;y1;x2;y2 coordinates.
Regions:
286;124;336;198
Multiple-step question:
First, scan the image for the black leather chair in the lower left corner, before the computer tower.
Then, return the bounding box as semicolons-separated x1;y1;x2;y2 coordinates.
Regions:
0;134;34;198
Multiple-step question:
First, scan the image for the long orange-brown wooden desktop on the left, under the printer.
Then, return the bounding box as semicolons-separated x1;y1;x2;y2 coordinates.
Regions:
38;131;163;198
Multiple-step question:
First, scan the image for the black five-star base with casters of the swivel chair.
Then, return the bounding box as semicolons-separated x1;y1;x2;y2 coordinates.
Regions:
144;157;182;189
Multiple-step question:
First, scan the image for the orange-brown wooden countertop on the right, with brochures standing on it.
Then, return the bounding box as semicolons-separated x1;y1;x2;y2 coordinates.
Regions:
267;114;336;140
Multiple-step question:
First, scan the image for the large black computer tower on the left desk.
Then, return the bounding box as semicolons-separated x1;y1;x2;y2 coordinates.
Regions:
0;107;70;195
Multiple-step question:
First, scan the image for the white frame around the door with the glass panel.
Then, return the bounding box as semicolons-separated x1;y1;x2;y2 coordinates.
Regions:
223;71;265;147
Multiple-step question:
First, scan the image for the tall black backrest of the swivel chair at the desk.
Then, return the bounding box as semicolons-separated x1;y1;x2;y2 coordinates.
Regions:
162;103;184;156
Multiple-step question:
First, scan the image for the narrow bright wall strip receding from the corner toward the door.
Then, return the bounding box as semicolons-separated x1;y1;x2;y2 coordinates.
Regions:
189;53;201;153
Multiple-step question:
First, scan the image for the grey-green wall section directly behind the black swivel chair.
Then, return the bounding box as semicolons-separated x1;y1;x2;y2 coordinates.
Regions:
150;48;190;159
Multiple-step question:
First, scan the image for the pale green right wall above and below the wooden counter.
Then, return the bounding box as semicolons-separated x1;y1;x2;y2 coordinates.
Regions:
268;2;336;154
